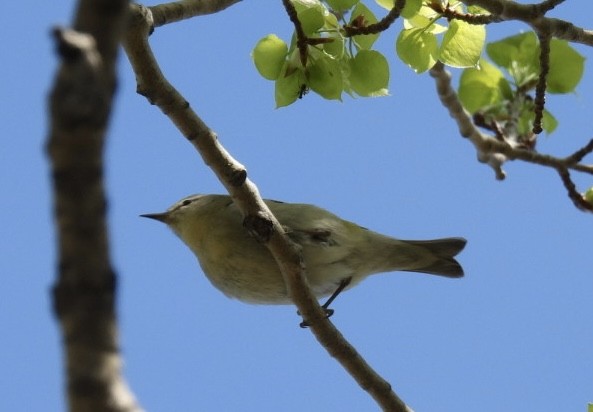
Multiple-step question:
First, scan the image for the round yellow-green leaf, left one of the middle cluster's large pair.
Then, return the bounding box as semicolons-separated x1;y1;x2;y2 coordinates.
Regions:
395;29;438;73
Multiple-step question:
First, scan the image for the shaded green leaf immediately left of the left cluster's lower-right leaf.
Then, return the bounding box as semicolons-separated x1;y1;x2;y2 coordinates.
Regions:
307;55;344;100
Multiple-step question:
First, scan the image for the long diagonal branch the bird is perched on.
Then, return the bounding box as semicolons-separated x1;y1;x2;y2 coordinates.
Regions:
124;5;410;411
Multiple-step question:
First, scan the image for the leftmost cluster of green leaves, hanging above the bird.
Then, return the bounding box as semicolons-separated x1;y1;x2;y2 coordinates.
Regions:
252;0;389;107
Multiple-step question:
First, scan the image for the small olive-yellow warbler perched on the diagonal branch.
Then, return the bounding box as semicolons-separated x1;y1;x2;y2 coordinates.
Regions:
141;195;466;307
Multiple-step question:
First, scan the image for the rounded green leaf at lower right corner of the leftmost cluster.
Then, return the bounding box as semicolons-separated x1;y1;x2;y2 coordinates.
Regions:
349;50;389;97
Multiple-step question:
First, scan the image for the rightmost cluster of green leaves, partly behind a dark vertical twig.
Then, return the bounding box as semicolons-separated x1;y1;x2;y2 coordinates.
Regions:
459;32;585;140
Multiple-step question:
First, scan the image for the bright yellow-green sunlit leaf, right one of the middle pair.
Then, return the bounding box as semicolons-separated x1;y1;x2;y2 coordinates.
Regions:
439;20;486;67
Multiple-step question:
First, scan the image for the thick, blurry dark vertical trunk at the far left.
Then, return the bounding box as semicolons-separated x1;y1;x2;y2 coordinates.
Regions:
47;0;140;412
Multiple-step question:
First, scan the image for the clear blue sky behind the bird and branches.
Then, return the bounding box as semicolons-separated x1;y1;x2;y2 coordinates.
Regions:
0;0;593;412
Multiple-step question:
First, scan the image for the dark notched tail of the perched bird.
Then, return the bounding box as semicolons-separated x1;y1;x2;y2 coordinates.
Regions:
405;237;466;278
